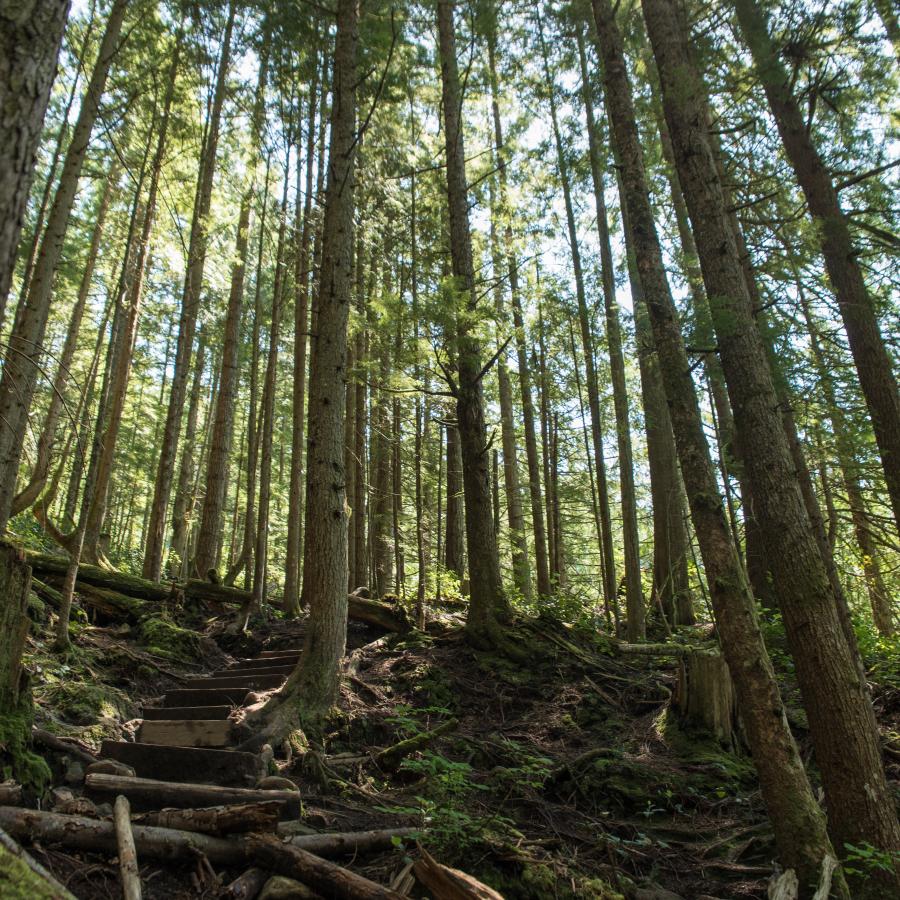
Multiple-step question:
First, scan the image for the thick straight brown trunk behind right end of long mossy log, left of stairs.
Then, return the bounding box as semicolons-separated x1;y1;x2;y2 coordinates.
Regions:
193;37;269;578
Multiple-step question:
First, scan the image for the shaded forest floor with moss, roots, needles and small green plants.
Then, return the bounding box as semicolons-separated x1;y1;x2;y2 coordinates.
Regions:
15;596;900;900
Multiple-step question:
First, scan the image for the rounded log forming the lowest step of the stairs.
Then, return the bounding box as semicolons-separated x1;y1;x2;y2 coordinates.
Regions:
84;768;300;819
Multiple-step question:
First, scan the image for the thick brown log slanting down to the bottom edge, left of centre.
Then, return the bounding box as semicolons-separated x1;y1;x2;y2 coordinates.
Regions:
245;835;400;900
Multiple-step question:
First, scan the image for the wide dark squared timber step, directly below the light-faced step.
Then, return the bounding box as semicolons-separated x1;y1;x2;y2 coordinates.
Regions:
100;741;263;787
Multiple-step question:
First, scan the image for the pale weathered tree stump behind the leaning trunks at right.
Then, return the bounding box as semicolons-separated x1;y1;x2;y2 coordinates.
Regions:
672;650;741;750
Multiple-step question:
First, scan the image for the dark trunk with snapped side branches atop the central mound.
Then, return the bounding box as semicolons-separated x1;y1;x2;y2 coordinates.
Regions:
437;0;510;646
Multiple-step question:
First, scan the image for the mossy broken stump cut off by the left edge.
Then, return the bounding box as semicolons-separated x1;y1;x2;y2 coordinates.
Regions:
0;542;50;786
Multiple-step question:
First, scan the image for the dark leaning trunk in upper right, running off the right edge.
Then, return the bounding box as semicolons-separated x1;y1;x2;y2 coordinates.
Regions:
734;0;900;536
